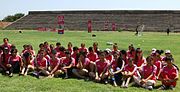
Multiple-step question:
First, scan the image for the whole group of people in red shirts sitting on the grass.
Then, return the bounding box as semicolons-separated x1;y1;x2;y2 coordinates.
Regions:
0;38;179;90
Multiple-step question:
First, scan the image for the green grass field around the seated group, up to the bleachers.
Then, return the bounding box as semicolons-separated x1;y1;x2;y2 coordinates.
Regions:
0;30;180;92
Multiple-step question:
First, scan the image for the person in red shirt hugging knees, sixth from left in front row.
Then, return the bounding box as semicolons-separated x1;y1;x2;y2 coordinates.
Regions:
59;50;75;79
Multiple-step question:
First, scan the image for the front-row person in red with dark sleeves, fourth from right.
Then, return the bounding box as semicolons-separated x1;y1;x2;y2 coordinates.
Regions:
109;52;125;87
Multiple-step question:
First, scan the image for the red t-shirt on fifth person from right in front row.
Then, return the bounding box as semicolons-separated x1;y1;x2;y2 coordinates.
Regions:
95;60;109;74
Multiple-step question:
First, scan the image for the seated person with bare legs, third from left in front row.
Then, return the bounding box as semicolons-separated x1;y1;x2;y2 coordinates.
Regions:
20;51;34;76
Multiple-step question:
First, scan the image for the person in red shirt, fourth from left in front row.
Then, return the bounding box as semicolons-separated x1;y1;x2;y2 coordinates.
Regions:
34;50;49;78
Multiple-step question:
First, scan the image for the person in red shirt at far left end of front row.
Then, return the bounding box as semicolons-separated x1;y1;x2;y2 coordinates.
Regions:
0;47;11;74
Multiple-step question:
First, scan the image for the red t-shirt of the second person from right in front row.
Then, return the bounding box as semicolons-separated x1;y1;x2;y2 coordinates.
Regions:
141;65;157;80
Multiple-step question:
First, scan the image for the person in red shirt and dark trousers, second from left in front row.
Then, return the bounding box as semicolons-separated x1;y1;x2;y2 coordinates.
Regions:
7;49;23;77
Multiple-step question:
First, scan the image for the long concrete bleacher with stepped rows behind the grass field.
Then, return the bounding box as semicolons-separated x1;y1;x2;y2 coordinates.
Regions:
6;10;180;32
